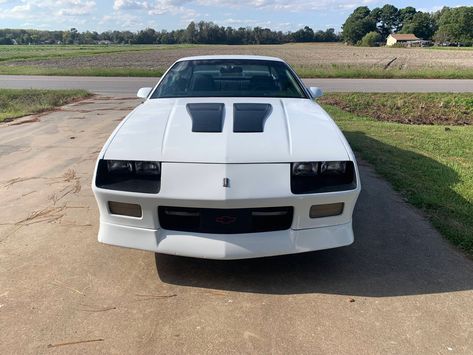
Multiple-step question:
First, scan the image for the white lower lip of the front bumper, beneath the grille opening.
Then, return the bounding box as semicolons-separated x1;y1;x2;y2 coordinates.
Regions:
99;222;353;259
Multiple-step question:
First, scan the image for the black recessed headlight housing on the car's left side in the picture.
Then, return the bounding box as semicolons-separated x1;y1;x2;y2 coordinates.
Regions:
95;159;161;194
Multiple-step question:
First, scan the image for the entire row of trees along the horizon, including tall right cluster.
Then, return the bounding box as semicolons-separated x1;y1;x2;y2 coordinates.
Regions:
0;4;473;46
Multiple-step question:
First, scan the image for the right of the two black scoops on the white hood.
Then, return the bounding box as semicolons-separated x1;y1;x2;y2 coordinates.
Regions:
233;104;273;133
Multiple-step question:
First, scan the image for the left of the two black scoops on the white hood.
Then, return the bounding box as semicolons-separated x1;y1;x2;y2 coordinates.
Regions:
186;103;225;133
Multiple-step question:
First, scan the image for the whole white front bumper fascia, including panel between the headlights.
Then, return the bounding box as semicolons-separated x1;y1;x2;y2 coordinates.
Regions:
92;163;360;259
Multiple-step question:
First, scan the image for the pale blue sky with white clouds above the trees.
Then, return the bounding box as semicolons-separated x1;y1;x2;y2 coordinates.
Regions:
0;0;471;32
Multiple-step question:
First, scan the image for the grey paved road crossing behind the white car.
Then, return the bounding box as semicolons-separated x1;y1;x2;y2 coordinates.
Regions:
0;75;473;96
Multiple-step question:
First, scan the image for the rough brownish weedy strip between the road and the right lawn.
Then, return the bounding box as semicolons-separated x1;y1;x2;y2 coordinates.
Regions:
319;93;473;125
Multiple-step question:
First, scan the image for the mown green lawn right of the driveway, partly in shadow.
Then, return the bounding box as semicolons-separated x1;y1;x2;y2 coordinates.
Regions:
323;94;473;256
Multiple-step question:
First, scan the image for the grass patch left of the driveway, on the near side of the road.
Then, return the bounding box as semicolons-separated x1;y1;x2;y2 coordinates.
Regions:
0;89;91;122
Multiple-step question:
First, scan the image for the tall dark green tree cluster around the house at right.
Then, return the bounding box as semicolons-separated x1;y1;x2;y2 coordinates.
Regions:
342;4;473;46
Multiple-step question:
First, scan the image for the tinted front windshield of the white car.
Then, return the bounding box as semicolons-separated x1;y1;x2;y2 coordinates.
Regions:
151;59;307;99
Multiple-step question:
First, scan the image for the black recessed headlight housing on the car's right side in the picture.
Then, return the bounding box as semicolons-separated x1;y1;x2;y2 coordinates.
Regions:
291;161;356;195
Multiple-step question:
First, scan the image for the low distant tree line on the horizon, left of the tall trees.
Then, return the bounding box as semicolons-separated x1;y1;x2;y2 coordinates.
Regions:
0;21;340;44
